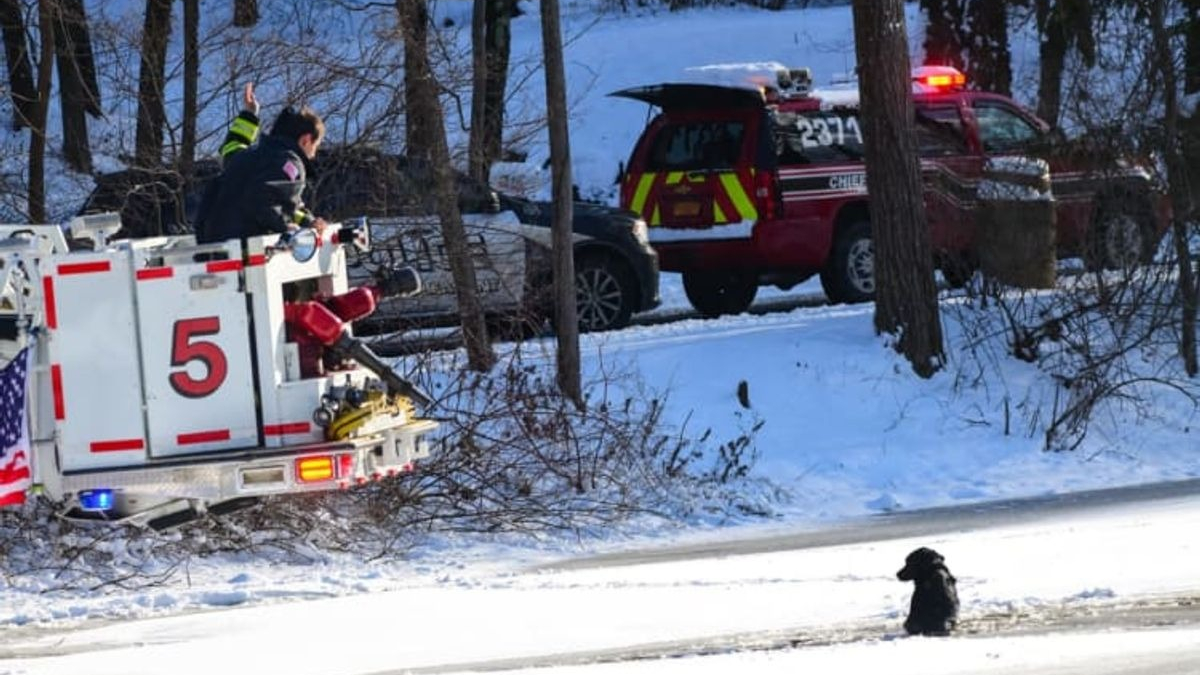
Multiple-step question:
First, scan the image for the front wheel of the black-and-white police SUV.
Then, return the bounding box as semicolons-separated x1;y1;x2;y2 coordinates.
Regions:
575;253;636;331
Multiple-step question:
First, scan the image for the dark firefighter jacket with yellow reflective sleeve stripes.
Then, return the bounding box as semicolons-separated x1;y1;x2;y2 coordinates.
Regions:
196;112;312;244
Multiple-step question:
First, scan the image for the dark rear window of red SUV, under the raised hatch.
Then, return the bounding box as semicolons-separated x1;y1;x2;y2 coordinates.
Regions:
647;121;745;172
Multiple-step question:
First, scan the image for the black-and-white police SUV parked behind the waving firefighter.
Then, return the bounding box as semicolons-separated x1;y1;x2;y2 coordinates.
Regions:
80;148;659;331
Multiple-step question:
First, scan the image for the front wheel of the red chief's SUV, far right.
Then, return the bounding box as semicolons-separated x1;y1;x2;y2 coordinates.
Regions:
1084;195;1157;269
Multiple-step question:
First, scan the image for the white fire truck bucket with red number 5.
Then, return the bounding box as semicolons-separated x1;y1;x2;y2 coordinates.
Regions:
0;214;437;527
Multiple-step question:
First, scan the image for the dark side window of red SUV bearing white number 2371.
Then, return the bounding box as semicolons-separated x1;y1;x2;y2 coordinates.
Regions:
770;109;863;165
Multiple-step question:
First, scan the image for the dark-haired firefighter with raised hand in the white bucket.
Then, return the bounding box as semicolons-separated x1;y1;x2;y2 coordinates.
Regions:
196;83;325;244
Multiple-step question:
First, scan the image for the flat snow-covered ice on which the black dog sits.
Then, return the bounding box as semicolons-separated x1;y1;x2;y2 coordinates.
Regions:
0;480;1200;675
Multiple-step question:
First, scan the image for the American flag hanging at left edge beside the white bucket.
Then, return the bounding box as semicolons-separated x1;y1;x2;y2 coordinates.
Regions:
0;347;32;506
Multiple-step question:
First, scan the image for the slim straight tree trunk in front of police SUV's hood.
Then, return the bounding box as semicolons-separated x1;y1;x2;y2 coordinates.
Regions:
541;0;583;410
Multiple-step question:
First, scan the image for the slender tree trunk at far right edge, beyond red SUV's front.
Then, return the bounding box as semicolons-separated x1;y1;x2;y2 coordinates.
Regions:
1150;0;1200;377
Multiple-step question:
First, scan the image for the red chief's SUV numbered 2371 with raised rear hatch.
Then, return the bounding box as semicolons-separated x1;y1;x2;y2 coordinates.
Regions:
613;66;1166;315
